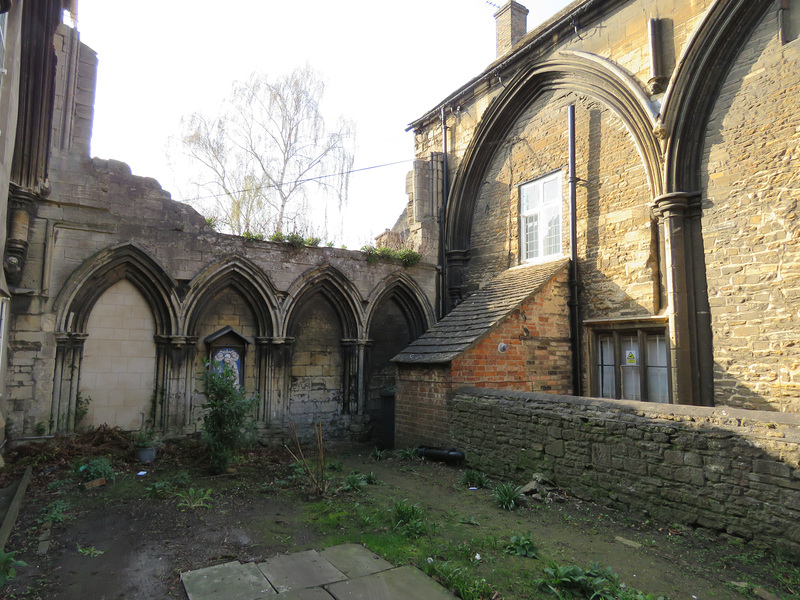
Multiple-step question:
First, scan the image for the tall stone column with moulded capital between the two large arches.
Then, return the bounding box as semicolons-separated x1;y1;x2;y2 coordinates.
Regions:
653;192;701;404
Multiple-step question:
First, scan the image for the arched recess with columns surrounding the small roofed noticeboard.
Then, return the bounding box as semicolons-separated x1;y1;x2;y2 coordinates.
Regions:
182;255;278;425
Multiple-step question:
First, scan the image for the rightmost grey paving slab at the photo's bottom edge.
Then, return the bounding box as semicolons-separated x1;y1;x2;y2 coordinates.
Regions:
325;565;455;600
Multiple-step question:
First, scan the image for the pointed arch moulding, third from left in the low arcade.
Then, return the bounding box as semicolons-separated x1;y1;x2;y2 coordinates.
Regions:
283;265;363;339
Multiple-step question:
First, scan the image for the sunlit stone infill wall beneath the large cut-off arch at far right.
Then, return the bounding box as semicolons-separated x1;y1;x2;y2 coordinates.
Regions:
702;6;800;412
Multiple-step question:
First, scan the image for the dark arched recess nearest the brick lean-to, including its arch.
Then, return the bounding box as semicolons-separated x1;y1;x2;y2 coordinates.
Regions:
364;271;434;448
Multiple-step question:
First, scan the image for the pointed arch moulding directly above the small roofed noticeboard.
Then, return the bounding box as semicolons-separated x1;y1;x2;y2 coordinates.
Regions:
182;254;278;337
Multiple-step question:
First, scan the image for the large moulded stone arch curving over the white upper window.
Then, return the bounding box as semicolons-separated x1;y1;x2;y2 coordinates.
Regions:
446;51;663;251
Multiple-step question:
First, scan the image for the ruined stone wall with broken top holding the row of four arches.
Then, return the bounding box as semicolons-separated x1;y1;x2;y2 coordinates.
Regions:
7;146;435;434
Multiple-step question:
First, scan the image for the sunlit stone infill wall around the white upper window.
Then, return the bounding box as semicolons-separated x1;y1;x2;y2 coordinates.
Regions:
466;92;660;318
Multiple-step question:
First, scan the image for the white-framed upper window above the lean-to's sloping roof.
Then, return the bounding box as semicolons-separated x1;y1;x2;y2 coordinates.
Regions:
519;171;562;262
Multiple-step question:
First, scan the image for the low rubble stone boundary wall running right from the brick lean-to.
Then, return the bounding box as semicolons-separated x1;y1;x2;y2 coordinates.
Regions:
448;389;800;553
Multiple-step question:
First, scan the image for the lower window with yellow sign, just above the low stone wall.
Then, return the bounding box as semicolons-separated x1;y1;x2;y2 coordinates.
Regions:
593;329;670;403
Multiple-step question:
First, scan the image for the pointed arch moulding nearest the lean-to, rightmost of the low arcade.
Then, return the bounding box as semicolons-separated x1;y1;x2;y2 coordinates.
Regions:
365;271;434;340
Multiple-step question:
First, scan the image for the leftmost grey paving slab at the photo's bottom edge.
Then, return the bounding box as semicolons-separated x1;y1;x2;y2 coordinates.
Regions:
181;561;278;600
